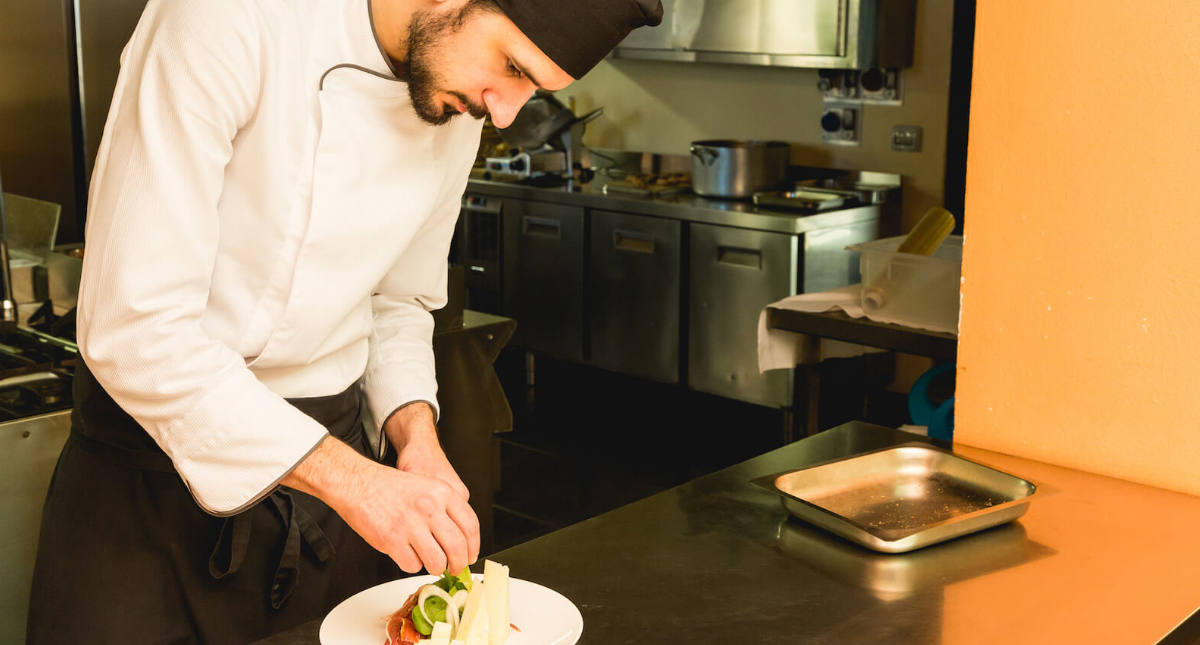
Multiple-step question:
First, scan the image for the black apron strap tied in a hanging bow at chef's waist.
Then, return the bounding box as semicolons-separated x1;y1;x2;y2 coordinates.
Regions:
209;489;336;609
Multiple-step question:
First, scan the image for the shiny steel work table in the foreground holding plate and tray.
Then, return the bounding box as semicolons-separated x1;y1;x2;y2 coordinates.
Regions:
250;422;1200;645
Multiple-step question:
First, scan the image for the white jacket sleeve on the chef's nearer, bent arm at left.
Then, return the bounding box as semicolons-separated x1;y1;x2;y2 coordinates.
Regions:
78;0;328;516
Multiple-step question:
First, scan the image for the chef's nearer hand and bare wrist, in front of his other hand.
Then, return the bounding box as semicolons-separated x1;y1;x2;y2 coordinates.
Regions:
282;438;479;575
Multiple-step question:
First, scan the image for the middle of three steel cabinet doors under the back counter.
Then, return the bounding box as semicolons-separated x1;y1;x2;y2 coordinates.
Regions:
588;211;682;382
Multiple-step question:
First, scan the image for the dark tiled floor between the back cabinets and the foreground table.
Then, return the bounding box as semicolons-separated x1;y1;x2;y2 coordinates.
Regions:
494;350;782;550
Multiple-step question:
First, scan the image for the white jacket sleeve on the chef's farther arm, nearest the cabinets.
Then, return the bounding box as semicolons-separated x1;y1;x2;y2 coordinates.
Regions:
362;139;479;456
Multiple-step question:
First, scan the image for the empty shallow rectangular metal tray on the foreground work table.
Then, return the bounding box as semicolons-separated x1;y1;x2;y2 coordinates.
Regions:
754;442;1037;553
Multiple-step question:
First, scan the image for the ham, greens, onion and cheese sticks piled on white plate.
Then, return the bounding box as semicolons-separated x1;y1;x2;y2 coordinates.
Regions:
384;560;520;645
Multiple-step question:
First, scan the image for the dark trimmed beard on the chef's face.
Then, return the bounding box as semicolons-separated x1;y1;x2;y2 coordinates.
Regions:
407;6;487;126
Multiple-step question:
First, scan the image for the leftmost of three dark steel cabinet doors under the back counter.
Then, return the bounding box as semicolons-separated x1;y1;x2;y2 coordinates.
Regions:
503;200;586;362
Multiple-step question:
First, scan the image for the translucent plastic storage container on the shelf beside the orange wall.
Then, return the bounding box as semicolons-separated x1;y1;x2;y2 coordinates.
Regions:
846;235;962;332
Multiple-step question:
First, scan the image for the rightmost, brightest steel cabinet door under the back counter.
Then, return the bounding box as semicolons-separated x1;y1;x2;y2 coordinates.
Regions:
688;224;799;406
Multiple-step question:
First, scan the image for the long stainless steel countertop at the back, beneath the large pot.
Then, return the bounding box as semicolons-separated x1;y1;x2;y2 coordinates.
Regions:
467;179;881;235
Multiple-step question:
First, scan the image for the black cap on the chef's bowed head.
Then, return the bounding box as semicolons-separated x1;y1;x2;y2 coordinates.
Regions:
497;0;662;79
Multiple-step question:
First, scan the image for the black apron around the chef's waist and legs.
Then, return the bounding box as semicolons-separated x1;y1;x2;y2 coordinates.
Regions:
26;361;401;645
